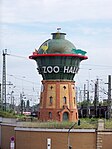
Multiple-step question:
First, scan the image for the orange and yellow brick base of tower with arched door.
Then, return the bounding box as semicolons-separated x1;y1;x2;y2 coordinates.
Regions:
39;80;78;122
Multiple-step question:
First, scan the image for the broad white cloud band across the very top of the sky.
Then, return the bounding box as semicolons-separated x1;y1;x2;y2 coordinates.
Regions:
1;0;112;23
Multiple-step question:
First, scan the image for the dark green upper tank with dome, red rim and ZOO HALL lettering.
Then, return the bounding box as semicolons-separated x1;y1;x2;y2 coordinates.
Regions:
30;32;87;80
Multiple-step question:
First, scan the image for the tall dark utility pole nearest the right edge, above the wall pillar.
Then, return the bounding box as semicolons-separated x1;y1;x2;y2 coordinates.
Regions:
107;75;112;118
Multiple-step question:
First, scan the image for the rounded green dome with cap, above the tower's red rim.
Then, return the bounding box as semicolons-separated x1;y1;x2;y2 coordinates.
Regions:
38;32;76;54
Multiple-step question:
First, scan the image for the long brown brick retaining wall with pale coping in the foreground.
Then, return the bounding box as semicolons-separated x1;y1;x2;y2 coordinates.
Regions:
0;123;112;149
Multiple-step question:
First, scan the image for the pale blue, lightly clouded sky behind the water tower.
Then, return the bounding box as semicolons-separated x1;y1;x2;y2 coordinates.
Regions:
0;0;112;104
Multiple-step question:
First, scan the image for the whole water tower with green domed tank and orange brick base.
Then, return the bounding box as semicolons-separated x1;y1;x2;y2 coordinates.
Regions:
29;31;87;121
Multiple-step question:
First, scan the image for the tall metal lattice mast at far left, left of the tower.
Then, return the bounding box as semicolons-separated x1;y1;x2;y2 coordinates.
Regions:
1;49;7;110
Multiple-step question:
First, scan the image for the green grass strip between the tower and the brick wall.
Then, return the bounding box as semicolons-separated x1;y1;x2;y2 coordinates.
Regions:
0;110;112;129
